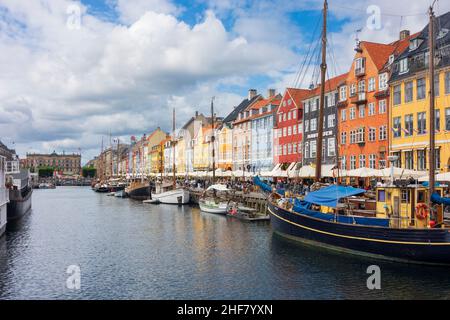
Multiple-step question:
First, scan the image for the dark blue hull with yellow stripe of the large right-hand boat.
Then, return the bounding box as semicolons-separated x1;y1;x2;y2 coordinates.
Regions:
268;202;450;265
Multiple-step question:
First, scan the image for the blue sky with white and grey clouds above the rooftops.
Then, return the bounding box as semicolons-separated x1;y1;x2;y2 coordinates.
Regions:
0;0;450;163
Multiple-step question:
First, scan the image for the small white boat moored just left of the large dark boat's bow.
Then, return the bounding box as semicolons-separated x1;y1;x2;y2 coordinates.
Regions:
198;184;231;215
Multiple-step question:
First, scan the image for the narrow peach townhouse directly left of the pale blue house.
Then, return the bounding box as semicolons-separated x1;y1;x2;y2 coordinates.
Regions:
233;89;263;171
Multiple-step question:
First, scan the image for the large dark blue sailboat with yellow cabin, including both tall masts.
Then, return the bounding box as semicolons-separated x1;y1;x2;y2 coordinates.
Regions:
262;1;450;265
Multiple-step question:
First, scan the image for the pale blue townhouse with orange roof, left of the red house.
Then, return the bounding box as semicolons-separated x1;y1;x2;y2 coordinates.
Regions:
249;89;282;174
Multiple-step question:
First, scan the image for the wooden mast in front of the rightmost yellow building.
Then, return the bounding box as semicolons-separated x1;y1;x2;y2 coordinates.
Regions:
428;5;436;205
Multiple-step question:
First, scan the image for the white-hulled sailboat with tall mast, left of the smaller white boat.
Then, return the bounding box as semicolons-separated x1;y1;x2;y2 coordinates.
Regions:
151;109;190;205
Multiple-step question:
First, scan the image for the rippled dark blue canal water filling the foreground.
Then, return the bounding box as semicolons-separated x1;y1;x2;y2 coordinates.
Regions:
0;187;450;299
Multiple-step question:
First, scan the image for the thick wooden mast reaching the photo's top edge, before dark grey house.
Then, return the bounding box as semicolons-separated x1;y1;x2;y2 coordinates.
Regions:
315;0;328;182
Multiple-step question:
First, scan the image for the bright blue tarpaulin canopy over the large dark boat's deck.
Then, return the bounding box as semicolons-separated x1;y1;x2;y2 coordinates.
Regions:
305;185;366;208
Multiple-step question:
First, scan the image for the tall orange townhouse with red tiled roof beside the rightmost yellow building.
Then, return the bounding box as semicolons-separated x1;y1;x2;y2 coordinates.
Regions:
338;31;409;170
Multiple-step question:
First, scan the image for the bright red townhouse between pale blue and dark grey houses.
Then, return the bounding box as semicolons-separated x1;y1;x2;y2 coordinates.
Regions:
273;88;310;168
